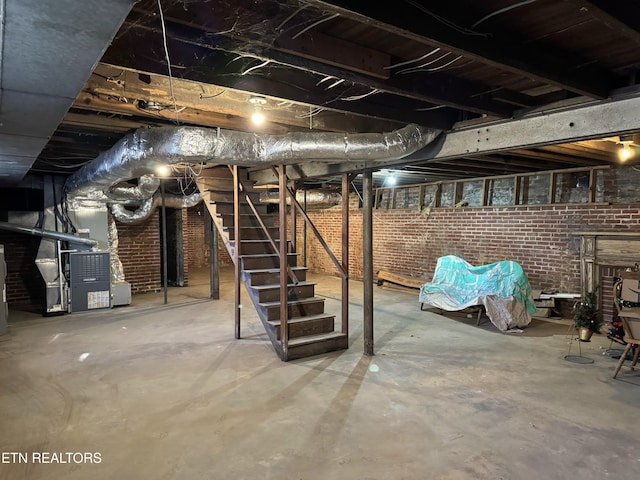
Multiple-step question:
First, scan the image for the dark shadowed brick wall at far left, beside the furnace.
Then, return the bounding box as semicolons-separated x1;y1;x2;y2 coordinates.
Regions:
0;231;46;311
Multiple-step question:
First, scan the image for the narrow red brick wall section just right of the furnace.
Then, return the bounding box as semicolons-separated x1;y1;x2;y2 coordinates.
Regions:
117;210;162;294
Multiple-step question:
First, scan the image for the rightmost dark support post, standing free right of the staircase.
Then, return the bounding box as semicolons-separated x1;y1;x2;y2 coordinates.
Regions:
362;171;373;356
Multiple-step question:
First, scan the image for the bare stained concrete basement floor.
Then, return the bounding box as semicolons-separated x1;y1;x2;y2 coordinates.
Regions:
0;269;640;480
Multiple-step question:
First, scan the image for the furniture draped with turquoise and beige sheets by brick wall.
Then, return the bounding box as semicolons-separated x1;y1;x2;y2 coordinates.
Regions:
419;255;536;332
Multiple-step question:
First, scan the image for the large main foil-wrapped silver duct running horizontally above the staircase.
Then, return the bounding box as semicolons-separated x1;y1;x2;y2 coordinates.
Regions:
65;125;440;199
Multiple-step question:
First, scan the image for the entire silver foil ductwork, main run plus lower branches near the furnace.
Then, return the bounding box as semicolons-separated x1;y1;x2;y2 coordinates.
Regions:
58;125;440;304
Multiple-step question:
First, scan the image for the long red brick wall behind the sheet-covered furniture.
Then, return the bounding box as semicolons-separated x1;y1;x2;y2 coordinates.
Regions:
299;198;640;292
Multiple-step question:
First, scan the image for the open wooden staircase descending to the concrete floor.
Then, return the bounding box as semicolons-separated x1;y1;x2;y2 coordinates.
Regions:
197;166;348;361
